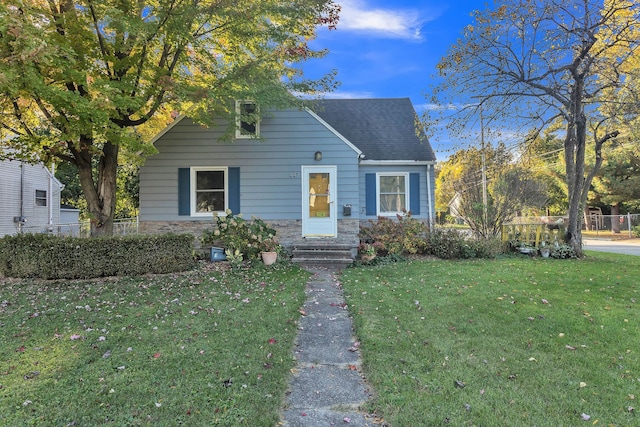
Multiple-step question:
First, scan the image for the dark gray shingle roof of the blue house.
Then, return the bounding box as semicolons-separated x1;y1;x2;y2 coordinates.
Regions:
312;98;436;161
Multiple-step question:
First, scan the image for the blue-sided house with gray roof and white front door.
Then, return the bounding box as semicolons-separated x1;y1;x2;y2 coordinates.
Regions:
140;98;436;252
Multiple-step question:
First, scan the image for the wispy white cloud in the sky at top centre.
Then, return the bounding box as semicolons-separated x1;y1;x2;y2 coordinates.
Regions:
338;0;427;40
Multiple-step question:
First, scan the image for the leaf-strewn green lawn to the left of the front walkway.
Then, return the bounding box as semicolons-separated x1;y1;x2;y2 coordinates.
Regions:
0;265;308;427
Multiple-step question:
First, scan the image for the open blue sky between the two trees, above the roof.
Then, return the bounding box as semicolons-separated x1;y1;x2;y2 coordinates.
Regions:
303;0;492;160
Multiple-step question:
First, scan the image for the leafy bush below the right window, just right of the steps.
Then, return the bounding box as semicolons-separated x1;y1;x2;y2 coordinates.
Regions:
360;212;429;255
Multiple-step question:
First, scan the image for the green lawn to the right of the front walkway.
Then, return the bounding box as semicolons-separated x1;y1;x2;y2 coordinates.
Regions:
342;252;640;426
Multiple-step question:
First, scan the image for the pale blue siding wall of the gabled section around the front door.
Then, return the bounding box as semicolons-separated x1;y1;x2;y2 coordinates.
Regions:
140;110;360;221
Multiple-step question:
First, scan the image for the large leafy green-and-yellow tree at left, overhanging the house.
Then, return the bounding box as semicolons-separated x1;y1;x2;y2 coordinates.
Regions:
0;0;339;235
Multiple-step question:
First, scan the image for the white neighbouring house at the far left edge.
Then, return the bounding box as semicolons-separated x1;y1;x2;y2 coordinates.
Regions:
0;160;64;236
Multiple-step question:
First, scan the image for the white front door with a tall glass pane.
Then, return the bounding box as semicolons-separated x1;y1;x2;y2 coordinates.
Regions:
302;166;338;237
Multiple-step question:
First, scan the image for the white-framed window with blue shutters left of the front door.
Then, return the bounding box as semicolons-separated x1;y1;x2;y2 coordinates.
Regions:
191;168;227;216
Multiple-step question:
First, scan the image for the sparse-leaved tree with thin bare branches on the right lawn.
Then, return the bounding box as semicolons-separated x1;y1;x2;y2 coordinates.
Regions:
428;0;640;254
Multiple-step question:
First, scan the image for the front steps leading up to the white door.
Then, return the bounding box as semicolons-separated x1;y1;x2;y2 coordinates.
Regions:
290;239;357;267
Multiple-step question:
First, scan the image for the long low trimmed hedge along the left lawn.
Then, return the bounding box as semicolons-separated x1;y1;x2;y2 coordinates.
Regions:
0;234;195;279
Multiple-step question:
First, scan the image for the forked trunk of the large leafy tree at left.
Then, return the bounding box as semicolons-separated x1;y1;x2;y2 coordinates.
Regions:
76;142;118;237
